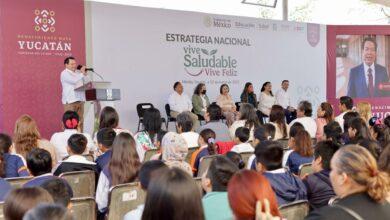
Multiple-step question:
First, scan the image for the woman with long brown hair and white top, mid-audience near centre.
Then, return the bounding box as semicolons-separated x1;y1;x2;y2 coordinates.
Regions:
229;103;260;141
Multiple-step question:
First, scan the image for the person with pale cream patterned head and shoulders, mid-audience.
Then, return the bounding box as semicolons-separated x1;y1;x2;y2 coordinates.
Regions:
161;132;192;175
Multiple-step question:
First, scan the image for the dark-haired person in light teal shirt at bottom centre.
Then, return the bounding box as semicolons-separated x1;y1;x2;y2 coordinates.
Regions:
202;156;238;220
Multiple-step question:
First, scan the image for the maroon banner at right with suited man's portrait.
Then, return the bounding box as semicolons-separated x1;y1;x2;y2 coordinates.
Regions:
327;26;390;118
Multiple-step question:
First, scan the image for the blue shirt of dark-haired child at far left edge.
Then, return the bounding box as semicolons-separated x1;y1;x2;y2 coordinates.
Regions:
3;153;30;178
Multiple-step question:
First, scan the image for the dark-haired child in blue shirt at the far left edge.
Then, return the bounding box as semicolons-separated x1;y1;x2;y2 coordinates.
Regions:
0;133;30;178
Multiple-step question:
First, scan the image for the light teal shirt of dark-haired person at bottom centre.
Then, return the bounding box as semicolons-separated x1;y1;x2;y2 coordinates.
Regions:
202;192;234;220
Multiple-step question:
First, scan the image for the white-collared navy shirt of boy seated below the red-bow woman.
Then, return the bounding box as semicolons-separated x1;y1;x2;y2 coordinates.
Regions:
54;155;99;176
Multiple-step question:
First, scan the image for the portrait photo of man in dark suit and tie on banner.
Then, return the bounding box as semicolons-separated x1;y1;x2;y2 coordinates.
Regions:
335;35;390;98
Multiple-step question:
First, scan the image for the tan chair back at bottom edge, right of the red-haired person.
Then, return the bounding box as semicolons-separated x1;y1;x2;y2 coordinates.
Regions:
279;200;309;220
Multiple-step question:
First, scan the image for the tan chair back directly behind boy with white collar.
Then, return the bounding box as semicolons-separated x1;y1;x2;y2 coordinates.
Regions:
60;170;96;198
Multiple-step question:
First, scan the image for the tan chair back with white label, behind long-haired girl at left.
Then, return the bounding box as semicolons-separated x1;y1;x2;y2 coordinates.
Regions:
108;182;146;220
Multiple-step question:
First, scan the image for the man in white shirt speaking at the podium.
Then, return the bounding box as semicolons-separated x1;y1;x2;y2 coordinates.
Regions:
61;57;86;132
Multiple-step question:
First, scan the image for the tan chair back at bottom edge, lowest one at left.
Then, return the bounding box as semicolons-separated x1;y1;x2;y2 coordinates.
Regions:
70;197;96;220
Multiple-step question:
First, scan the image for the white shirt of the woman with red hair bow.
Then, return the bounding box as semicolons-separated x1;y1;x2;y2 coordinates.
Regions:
50;129;96;161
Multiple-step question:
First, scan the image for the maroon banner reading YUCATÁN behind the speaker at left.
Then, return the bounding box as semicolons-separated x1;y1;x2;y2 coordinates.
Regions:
0;0;85;138
